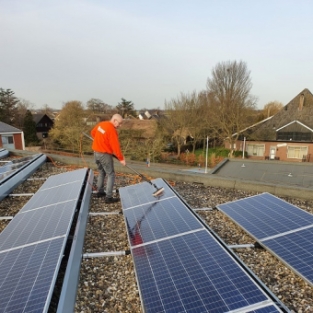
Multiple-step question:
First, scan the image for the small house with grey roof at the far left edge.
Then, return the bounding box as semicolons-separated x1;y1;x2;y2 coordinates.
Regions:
0;122;25;150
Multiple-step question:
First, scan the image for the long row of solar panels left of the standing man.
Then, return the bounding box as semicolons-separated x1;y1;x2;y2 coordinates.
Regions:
0;169;87;313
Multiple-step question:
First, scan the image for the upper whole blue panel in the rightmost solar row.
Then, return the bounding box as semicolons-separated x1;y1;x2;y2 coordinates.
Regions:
217;193;313;240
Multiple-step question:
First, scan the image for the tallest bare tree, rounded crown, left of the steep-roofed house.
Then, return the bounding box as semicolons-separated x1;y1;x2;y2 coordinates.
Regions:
207;61;256;156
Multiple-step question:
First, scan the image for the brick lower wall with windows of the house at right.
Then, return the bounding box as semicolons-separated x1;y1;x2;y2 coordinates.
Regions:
230;141;313;162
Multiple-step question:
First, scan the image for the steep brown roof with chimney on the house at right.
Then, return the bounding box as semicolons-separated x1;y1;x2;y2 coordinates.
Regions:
247;88;313;141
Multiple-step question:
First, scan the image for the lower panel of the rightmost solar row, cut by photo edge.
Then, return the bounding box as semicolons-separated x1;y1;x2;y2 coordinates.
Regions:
262;227;313;284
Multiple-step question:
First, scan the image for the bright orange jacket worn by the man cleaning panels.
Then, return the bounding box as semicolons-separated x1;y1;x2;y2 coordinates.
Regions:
90;121;124;161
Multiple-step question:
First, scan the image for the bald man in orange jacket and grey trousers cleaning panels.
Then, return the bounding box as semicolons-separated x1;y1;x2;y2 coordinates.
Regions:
91;114;126;203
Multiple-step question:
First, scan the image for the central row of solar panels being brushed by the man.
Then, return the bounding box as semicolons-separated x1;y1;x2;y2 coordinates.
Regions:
120;179;282;313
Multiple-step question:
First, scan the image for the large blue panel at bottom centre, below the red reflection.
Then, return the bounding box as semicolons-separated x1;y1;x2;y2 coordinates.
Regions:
133;230;276;312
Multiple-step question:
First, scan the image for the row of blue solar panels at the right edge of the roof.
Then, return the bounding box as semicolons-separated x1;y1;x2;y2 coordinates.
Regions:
217;193;313;285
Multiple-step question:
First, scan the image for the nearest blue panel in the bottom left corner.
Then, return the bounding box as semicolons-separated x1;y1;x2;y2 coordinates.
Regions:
0;238;64;313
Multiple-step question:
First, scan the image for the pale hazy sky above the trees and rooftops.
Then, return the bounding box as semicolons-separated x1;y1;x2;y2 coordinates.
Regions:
0;0;313;110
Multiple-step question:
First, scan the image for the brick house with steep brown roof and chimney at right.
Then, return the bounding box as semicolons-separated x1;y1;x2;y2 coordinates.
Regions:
226;89;313;162
